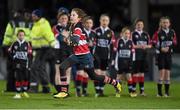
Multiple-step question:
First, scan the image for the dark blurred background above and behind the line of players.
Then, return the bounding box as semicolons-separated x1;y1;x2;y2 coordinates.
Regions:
0;0;180;80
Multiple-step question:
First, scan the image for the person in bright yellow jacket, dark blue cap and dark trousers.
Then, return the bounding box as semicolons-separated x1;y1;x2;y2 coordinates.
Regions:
30;9;55;93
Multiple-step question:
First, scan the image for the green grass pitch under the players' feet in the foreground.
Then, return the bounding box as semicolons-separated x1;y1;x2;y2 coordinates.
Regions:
0;81;180;109
